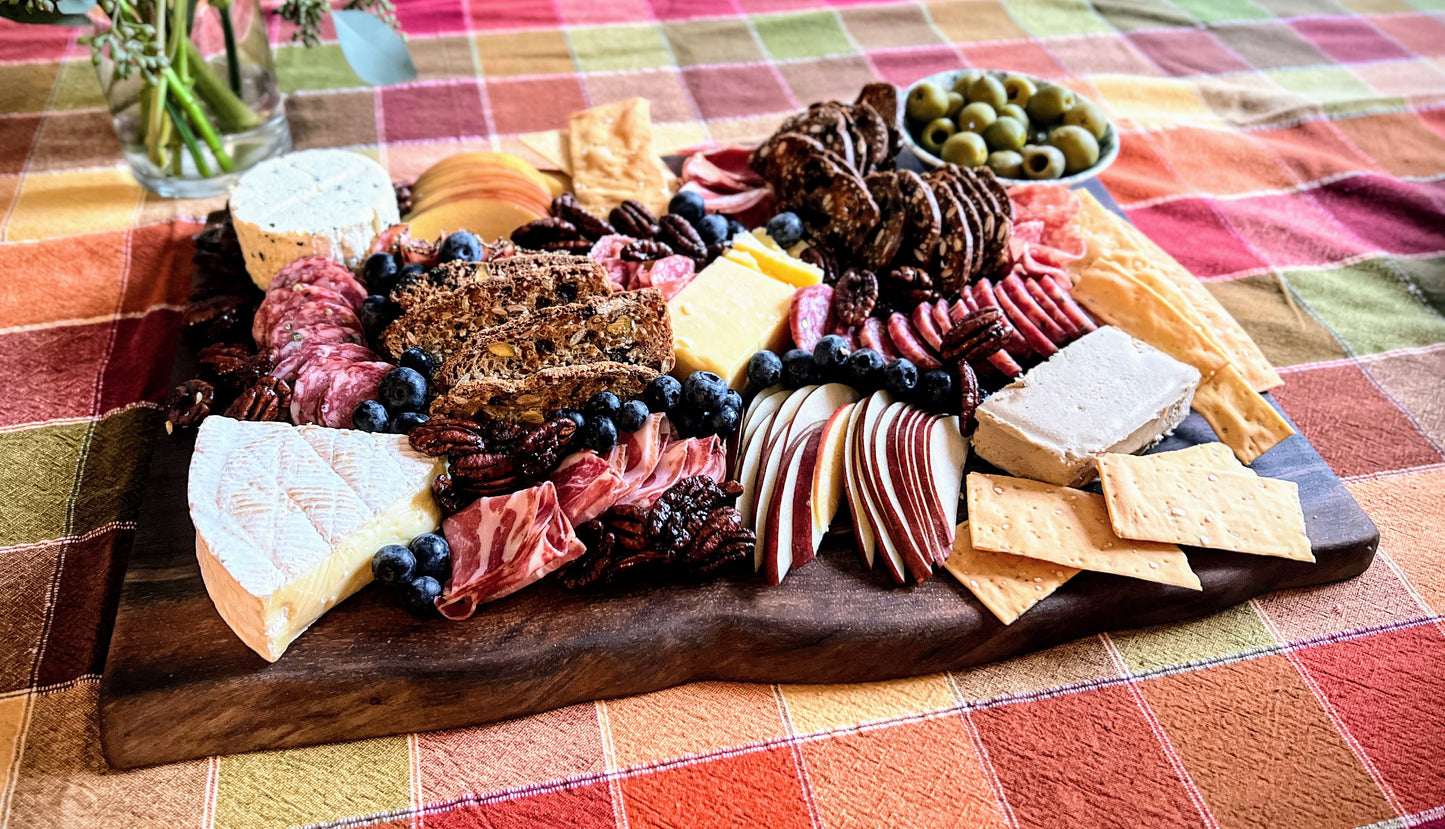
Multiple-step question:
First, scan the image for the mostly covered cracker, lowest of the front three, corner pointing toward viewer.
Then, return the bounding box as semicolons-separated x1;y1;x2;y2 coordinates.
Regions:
944;521;1079;624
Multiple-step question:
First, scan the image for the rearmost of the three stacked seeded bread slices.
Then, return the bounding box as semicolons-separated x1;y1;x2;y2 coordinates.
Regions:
381;260;611;364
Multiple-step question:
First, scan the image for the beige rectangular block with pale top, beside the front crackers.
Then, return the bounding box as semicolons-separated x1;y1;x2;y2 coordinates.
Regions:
974;326;1199;487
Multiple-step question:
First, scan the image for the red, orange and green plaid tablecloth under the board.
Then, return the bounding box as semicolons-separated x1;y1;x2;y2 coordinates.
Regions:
0;0;1445;829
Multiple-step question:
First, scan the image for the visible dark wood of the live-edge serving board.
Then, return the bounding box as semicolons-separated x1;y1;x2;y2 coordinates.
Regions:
101;184;1379;768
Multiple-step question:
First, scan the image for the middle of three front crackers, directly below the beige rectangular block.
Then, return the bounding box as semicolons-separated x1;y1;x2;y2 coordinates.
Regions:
968;472;1202;591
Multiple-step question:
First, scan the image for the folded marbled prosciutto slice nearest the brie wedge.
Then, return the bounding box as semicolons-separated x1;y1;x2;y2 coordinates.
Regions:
436;481;587;620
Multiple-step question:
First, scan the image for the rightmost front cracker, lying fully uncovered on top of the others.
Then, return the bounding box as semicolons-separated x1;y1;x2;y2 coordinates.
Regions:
1098;455;1315;562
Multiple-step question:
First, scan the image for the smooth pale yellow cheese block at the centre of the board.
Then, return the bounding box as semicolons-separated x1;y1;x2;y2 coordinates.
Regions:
668;257;793;389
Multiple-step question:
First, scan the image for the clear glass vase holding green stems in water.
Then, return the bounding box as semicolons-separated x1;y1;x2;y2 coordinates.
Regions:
95;0;290;198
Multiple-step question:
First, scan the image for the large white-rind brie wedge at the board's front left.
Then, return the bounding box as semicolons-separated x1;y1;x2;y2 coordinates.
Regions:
188;416;444;661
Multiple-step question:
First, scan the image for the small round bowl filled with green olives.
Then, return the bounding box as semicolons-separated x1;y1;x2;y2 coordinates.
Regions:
903;69;1118;185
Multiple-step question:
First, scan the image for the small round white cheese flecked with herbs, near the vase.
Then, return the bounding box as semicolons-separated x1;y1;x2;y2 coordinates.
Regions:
231;150;402;290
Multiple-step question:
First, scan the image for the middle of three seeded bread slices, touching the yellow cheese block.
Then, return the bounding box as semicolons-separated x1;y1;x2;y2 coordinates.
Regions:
432;287;673;391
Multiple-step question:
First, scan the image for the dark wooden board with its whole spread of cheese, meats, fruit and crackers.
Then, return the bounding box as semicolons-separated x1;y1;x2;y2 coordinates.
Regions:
103;81;1377;765
